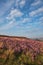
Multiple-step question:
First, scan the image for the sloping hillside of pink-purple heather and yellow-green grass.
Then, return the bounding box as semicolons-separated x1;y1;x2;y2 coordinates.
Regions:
0;36;43;65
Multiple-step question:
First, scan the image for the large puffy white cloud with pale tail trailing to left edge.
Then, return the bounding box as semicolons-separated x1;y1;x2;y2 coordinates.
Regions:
0;9;23;30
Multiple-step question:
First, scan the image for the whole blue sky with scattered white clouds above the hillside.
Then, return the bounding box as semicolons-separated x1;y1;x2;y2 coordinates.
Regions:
0;0;43;38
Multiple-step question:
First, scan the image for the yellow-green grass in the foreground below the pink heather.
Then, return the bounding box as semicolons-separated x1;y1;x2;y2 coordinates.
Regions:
0;50;43;65
